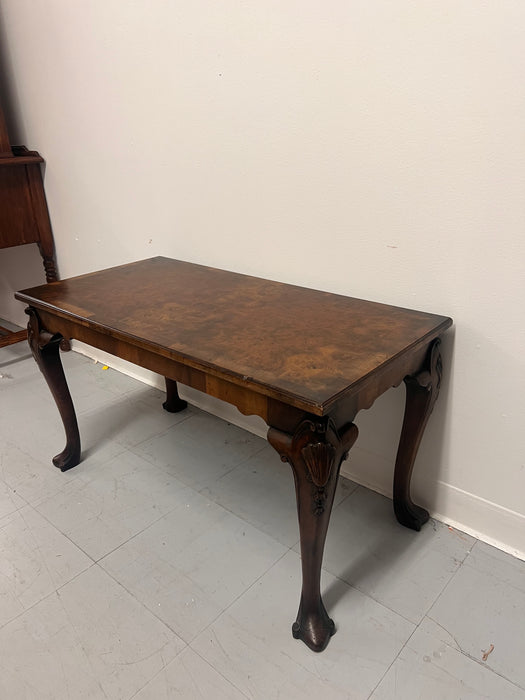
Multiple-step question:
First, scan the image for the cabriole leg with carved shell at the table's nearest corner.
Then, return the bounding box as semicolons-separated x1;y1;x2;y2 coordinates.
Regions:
268;417;357;651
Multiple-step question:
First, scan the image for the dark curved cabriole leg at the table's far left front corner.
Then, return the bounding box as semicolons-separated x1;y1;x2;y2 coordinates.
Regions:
26;307;80;472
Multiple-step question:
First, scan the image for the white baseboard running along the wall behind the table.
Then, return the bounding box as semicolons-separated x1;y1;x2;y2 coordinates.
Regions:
73;341;525;560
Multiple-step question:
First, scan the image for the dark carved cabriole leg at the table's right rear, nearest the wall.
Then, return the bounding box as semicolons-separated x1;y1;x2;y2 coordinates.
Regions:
394;338;442;531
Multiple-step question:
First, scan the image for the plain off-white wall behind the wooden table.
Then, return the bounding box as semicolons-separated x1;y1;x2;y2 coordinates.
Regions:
0;0;525;556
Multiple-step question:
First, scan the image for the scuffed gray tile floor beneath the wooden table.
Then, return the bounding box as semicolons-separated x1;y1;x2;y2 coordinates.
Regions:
0;343;525;700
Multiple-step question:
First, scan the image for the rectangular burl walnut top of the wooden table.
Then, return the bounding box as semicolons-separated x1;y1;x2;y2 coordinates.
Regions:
16;257;451;413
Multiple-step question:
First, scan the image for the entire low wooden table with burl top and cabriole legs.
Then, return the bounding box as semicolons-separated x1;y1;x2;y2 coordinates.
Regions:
16;257;452;651
